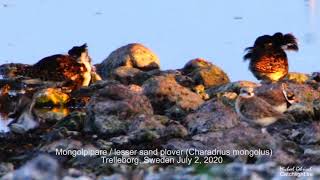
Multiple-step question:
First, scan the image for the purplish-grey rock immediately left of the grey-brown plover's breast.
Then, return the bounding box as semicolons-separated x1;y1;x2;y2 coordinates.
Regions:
183;101;239;134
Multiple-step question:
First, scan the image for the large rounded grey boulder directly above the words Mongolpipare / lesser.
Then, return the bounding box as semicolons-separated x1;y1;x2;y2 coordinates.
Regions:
85;83;153;135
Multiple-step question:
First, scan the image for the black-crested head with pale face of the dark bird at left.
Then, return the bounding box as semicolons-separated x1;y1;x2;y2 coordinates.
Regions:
68;43;91;64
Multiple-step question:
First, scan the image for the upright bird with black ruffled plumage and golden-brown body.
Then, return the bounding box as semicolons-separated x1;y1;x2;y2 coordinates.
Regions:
243;32;298;82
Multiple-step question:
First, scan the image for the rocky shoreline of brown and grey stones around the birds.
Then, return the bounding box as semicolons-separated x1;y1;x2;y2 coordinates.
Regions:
0;44;320;180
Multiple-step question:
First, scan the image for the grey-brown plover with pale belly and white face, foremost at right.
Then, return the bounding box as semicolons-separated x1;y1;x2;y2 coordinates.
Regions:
236;87;286;127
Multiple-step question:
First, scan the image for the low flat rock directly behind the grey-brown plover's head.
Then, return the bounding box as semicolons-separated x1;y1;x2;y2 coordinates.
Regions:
206;81;259;98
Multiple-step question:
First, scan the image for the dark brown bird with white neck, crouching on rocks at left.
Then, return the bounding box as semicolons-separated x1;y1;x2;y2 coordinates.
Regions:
26;44;101;87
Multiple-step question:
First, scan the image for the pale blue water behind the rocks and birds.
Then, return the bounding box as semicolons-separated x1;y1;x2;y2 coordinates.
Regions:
0;0;320;81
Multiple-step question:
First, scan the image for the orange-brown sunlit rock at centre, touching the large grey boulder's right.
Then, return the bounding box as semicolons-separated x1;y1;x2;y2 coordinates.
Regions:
142;75;203;114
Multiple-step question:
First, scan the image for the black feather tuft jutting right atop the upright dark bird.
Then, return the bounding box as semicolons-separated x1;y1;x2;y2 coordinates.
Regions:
272;32;299;51
